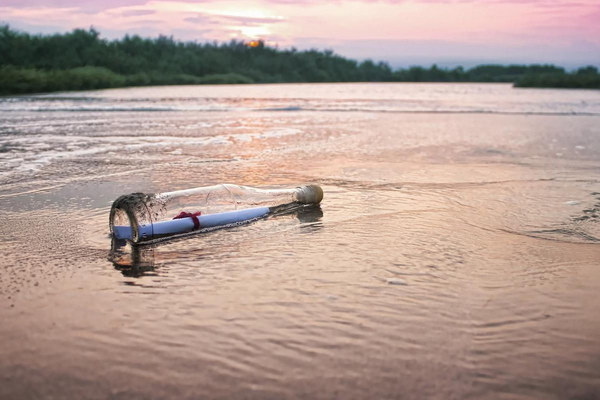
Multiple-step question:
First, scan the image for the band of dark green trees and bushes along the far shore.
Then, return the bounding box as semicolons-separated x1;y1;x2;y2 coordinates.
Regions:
0;25;600;94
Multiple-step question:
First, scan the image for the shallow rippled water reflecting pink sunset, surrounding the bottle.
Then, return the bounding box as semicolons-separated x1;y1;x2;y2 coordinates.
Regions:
0;84;600;399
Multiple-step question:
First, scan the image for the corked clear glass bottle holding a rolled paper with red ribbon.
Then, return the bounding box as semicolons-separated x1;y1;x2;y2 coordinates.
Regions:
109;184;323;243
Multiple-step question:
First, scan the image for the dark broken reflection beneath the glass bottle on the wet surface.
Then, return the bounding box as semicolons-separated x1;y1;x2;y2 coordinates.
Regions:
108;205;323;278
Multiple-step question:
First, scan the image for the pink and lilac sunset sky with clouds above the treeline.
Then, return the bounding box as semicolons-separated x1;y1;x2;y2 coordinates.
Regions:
0;0;600;68
